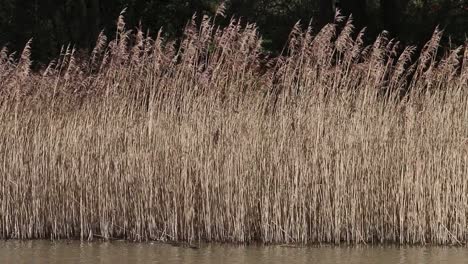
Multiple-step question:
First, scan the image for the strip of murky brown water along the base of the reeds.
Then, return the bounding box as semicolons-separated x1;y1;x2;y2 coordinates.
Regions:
0;241;468;264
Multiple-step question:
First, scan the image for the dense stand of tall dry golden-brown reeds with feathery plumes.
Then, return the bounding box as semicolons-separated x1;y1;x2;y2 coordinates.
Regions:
0;10;468;244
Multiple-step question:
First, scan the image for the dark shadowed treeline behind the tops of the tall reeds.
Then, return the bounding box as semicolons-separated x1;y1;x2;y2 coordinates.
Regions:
0;0;468;61
